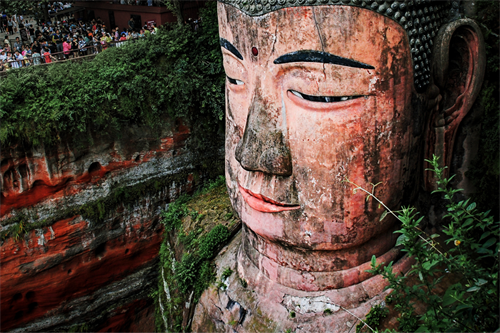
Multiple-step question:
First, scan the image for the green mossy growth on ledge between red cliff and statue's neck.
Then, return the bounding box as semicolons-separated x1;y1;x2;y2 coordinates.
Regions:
153;177;232;332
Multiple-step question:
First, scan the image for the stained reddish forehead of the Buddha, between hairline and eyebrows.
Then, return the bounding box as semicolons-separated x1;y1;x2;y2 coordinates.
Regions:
219;3;410;66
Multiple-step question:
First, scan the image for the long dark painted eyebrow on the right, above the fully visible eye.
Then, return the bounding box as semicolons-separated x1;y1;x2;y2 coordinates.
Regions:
274;50;375;69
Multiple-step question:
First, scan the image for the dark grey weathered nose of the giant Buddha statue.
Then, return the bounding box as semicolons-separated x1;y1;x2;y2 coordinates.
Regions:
235;96;292;176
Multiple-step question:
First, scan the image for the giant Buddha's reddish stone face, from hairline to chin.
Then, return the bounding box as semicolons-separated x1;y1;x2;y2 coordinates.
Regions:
222;3;422;250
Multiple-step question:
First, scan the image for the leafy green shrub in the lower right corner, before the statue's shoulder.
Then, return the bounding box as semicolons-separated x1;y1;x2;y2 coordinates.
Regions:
370;157;500;332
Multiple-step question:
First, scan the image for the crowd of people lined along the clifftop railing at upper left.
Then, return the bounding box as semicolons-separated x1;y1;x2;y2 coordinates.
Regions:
0;16;157;71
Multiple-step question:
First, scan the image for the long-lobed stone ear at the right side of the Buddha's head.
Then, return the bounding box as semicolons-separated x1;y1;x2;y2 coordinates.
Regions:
424;19;486;190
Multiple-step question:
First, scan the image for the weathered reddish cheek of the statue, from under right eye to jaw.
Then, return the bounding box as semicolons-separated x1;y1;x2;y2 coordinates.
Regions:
287;97;399;243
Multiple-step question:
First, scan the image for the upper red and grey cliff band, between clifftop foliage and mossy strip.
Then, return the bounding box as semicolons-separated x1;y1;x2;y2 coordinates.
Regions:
0;118;190;222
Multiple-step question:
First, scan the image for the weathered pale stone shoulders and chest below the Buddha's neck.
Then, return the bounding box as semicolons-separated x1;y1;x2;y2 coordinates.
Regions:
193;234;410;333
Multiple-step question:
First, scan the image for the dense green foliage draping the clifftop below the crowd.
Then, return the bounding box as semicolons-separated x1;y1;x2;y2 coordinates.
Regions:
0;3;224;146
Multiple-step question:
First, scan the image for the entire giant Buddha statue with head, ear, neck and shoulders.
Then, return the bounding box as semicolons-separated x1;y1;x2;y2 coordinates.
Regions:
193;0;485;332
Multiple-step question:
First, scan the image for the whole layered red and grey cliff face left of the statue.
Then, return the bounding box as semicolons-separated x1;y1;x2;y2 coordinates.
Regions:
0;121;221;332
